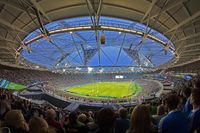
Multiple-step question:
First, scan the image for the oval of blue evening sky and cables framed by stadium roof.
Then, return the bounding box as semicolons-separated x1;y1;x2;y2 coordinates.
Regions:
18;16;175;71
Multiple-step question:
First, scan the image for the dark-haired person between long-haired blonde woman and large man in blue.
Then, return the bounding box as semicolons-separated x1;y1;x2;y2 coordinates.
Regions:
153;105;165;126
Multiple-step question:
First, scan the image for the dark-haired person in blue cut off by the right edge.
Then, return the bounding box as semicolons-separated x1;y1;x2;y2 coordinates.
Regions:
188;89;200;133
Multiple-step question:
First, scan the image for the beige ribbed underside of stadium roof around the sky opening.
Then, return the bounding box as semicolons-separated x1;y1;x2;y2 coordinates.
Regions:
0;0;200;71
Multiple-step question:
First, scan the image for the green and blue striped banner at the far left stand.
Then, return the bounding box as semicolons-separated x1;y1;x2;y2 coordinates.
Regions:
0;79;27;91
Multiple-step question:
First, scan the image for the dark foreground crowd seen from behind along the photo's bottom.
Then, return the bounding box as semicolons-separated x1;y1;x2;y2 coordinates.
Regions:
0;73;200;133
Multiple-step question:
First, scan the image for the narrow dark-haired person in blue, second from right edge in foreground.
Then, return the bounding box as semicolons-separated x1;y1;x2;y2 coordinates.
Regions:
183;88;192;117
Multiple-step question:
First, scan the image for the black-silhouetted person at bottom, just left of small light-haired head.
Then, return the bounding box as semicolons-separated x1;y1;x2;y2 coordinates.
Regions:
64;112;87;133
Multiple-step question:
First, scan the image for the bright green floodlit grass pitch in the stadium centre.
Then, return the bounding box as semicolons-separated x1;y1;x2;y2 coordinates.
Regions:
65;82;142;98
